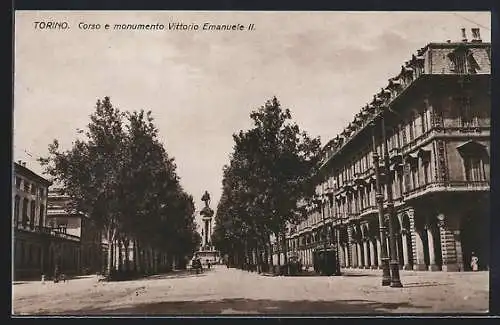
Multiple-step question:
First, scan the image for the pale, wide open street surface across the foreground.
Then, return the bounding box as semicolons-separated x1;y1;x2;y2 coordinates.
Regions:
13;266;489;315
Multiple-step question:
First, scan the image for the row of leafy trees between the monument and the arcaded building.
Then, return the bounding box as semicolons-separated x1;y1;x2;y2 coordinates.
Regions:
212;98;320;265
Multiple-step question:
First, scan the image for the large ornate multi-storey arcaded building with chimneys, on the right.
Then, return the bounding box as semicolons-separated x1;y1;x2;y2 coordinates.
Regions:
287;29;491;271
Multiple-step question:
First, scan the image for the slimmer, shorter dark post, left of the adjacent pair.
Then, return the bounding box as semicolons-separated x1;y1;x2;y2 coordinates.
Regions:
370;121;391;286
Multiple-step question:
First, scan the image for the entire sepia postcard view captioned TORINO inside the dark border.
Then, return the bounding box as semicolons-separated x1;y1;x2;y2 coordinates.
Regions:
11;10;491;317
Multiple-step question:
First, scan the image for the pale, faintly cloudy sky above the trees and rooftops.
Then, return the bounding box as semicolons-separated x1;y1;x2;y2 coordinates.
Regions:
13;11;491;229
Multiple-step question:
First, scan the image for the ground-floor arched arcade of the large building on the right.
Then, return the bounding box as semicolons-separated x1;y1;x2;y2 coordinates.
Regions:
289;193;490;271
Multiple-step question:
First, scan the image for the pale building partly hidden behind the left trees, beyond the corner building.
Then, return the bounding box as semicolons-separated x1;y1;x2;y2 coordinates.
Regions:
47;189;103;274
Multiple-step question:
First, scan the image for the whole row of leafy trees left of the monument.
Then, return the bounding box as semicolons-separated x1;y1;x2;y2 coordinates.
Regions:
39;97;201;275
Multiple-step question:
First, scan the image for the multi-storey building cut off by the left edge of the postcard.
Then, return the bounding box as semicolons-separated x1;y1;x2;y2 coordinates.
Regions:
12;161;79;279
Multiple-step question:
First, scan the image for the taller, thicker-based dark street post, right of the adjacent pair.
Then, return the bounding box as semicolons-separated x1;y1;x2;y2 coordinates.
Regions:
381;108;403;288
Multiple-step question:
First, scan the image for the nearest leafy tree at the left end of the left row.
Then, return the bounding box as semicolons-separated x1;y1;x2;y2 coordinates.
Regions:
39;97;126;272
